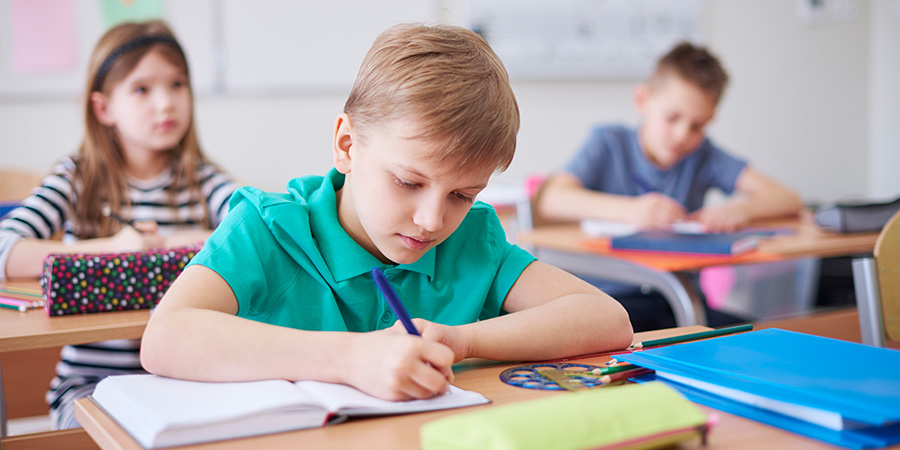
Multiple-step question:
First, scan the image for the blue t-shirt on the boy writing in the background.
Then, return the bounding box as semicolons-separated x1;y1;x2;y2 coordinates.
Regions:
565;125;747;212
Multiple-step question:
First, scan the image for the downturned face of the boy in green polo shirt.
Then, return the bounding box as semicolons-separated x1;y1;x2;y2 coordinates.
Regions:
335;114;493;264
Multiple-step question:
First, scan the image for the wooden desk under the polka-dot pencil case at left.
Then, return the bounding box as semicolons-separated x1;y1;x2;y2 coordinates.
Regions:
0;281;150;437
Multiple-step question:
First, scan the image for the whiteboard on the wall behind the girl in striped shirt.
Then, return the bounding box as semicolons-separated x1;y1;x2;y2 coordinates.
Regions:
0;0;440;99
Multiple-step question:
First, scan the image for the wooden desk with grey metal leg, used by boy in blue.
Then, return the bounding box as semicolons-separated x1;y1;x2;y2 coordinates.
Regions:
519;212;878;326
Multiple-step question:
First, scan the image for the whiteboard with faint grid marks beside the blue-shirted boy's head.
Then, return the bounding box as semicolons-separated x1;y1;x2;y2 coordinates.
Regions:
467;0;703;80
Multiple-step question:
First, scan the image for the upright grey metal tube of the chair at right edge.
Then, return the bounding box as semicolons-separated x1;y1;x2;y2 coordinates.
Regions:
853;258;884;347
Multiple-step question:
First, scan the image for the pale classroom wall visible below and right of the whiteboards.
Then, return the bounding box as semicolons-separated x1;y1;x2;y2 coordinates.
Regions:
0;0;900;202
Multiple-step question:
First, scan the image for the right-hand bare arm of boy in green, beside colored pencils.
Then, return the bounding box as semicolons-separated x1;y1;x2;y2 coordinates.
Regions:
416;261;632;361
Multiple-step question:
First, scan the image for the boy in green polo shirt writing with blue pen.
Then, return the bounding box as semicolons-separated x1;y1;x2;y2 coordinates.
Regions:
141;25;632;400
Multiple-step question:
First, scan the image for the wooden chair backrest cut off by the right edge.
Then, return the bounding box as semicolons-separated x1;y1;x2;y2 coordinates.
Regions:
874;212;900;341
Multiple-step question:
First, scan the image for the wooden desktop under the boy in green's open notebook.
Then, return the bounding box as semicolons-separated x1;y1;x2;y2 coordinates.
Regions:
75;324;900;450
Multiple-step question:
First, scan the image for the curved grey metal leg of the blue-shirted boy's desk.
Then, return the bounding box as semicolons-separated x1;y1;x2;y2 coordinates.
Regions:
532;247;706;327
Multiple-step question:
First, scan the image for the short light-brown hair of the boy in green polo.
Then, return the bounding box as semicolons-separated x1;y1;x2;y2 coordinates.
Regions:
344;24;519;171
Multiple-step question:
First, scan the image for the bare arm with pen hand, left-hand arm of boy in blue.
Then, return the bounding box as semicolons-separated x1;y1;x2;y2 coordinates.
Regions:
537;173;685;228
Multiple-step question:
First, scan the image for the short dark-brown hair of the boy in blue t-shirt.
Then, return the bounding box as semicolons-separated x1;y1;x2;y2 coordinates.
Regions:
650;42;728;103
